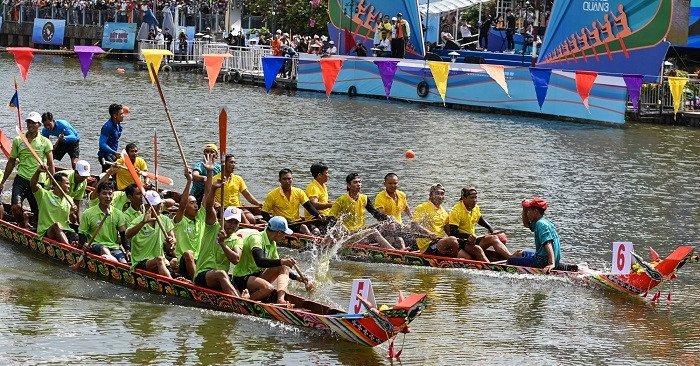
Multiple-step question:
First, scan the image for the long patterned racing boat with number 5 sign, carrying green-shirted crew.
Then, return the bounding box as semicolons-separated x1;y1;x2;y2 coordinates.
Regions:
0;204;426;347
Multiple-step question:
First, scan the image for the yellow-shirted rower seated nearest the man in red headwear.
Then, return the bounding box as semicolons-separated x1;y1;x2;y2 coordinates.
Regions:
449;187;519;262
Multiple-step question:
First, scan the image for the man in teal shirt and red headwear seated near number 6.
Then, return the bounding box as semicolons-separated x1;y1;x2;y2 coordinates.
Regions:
508;197;561;273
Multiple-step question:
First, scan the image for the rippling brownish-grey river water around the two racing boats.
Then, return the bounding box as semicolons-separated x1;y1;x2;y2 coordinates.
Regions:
0;54;700;365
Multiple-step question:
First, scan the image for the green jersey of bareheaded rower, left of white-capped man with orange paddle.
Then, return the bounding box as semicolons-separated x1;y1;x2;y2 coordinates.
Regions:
78;206;127;250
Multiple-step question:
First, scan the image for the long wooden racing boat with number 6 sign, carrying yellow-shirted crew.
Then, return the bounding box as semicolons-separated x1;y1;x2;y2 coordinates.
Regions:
241;224;696;298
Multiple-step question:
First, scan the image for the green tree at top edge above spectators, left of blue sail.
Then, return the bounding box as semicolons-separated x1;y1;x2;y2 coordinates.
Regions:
245;0;328;35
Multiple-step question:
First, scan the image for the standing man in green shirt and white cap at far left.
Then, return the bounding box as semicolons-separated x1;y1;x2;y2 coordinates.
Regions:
0;112;54;228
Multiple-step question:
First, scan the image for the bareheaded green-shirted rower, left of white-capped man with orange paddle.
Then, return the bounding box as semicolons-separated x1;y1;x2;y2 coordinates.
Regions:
78;181;128;263
